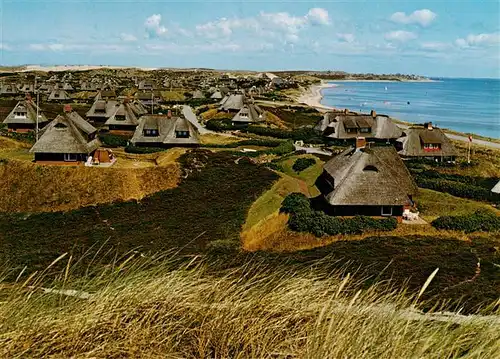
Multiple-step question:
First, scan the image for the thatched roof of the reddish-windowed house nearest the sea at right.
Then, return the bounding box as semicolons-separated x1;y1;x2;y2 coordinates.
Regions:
397;126;458;157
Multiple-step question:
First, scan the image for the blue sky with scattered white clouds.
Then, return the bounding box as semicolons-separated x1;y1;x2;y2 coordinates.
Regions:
0;0;500;78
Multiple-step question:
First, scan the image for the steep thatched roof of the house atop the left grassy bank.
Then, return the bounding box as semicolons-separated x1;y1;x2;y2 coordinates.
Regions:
30;112;101;154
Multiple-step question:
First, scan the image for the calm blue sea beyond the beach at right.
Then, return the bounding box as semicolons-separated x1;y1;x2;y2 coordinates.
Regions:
321;78;500;138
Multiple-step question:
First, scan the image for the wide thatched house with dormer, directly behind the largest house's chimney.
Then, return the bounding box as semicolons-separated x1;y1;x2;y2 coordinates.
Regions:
315;111;403;140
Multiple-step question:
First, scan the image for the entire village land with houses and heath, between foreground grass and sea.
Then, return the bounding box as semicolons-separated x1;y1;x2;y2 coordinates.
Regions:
0;69;500;320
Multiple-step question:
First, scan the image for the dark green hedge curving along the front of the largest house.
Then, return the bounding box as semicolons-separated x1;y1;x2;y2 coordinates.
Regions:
280;193;398;237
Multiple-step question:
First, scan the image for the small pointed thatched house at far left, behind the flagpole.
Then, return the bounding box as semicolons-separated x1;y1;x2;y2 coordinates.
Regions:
3;100;49;133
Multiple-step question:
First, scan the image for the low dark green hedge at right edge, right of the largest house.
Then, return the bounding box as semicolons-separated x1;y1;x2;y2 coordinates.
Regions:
431;210;500;233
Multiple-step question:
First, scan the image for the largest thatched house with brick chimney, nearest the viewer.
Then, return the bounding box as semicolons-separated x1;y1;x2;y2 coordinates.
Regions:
316;138;417;220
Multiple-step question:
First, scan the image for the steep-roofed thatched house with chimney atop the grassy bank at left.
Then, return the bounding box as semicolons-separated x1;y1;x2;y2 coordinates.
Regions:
30;105;101;164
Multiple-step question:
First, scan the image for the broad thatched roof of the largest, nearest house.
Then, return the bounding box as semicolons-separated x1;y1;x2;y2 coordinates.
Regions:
322;146;417;206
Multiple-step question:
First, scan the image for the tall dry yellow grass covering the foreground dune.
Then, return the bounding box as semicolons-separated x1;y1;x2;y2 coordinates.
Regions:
0;257;500;359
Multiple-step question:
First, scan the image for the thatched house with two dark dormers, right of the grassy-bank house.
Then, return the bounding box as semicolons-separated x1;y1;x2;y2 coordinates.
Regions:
131;115;200;148
